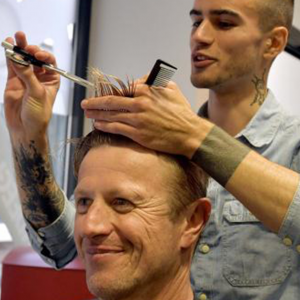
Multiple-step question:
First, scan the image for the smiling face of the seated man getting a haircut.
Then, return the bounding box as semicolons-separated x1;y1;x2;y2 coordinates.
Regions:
75;145;188;298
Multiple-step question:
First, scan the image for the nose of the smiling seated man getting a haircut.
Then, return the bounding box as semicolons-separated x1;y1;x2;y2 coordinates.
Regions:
83;202;113;238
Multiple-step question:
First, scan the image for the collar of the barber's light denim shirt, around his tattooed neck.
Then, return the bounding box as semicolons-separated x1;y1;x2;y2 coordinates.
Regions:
198;90;281;147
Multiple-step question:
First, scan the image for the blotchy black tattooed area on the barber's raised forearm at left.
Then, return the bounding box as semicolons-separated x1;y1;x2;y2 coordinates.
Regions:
14;141;64;228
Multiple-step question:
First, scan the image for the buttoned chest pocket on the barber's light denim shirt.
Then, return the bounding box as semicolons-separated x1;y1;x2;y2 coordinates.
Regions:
222;199;291;287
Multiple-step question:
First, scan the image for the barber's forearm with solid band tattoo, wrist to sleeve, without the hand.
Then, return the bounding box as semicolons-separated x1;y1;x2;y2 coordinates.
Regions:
192;124;299;233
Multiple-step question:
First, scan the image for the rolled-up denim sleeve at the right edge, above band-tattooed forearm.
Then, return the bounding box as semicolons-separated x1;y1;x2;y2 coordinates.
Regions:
278;184;300;253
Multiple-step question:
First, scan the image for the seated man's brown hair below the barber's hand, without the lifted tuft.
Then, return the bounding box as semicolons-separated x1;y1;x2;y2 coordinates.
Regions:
74;129;207;220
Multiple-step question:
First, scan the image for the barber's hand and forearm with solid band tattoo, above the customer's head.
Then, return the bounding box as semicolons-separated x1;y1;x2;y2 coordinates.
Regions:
82;83;299;232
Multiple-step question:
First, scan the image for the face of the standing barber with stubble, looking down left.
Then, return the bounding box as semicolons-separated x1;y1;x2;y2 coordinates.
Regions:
190;0;265;90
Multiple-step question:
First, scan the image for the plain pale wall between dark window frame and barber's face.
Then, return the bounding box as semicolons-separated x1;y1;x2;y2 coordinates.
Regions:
89;0;205;110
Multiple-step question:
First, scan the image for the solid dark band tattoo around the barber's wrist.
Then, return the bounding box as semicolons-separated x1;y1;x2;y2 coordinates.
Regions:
192;126;250;187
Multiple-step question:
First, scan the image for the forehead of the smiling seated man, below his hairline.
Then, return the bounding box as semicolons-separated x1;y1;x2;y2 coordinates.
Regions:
78;146;174;195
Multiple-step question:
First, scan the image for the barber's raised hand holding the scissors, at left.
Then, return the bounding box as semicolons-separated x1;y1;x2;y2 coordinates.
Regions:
4;32;60;143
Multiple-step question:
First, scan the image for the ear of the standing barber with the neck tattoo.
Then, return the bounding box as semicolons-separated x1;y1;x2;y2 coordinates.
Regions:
264;26;289;61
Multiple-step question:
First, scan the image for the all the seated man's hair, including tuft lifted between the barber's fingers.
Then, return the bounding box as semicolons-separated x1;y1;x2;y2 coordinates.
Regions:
74;68;208;220
